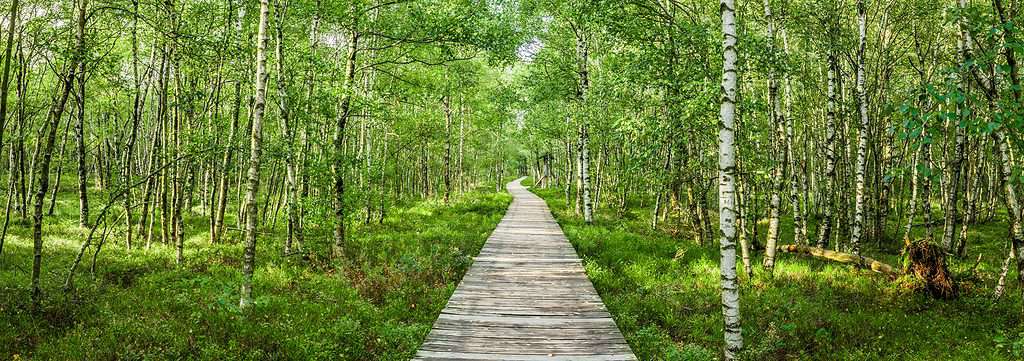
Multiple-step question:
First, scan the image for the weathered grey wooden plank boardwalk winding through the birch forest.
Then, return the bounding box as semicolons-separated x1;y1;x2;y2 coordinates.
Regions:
416;179;636;361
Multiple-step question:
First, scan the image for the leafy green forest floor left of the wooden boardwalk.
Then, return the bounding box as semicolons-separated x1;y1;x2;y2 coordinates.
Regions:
0;179;511;360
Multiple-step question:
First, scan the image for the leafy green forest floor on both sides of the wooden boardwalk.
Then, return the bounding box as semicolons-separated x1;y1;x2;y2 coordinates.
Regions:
0;177;1024;360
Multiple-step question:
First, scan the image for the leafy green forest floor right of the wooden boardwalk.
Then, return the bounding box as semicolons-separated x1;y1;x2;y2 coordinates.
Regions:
532;178;1024;360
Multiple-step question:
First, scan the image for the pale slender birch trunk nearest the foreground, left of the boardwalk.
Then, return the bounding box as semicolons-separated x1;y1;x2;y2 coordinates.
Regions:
239;0;270;309
